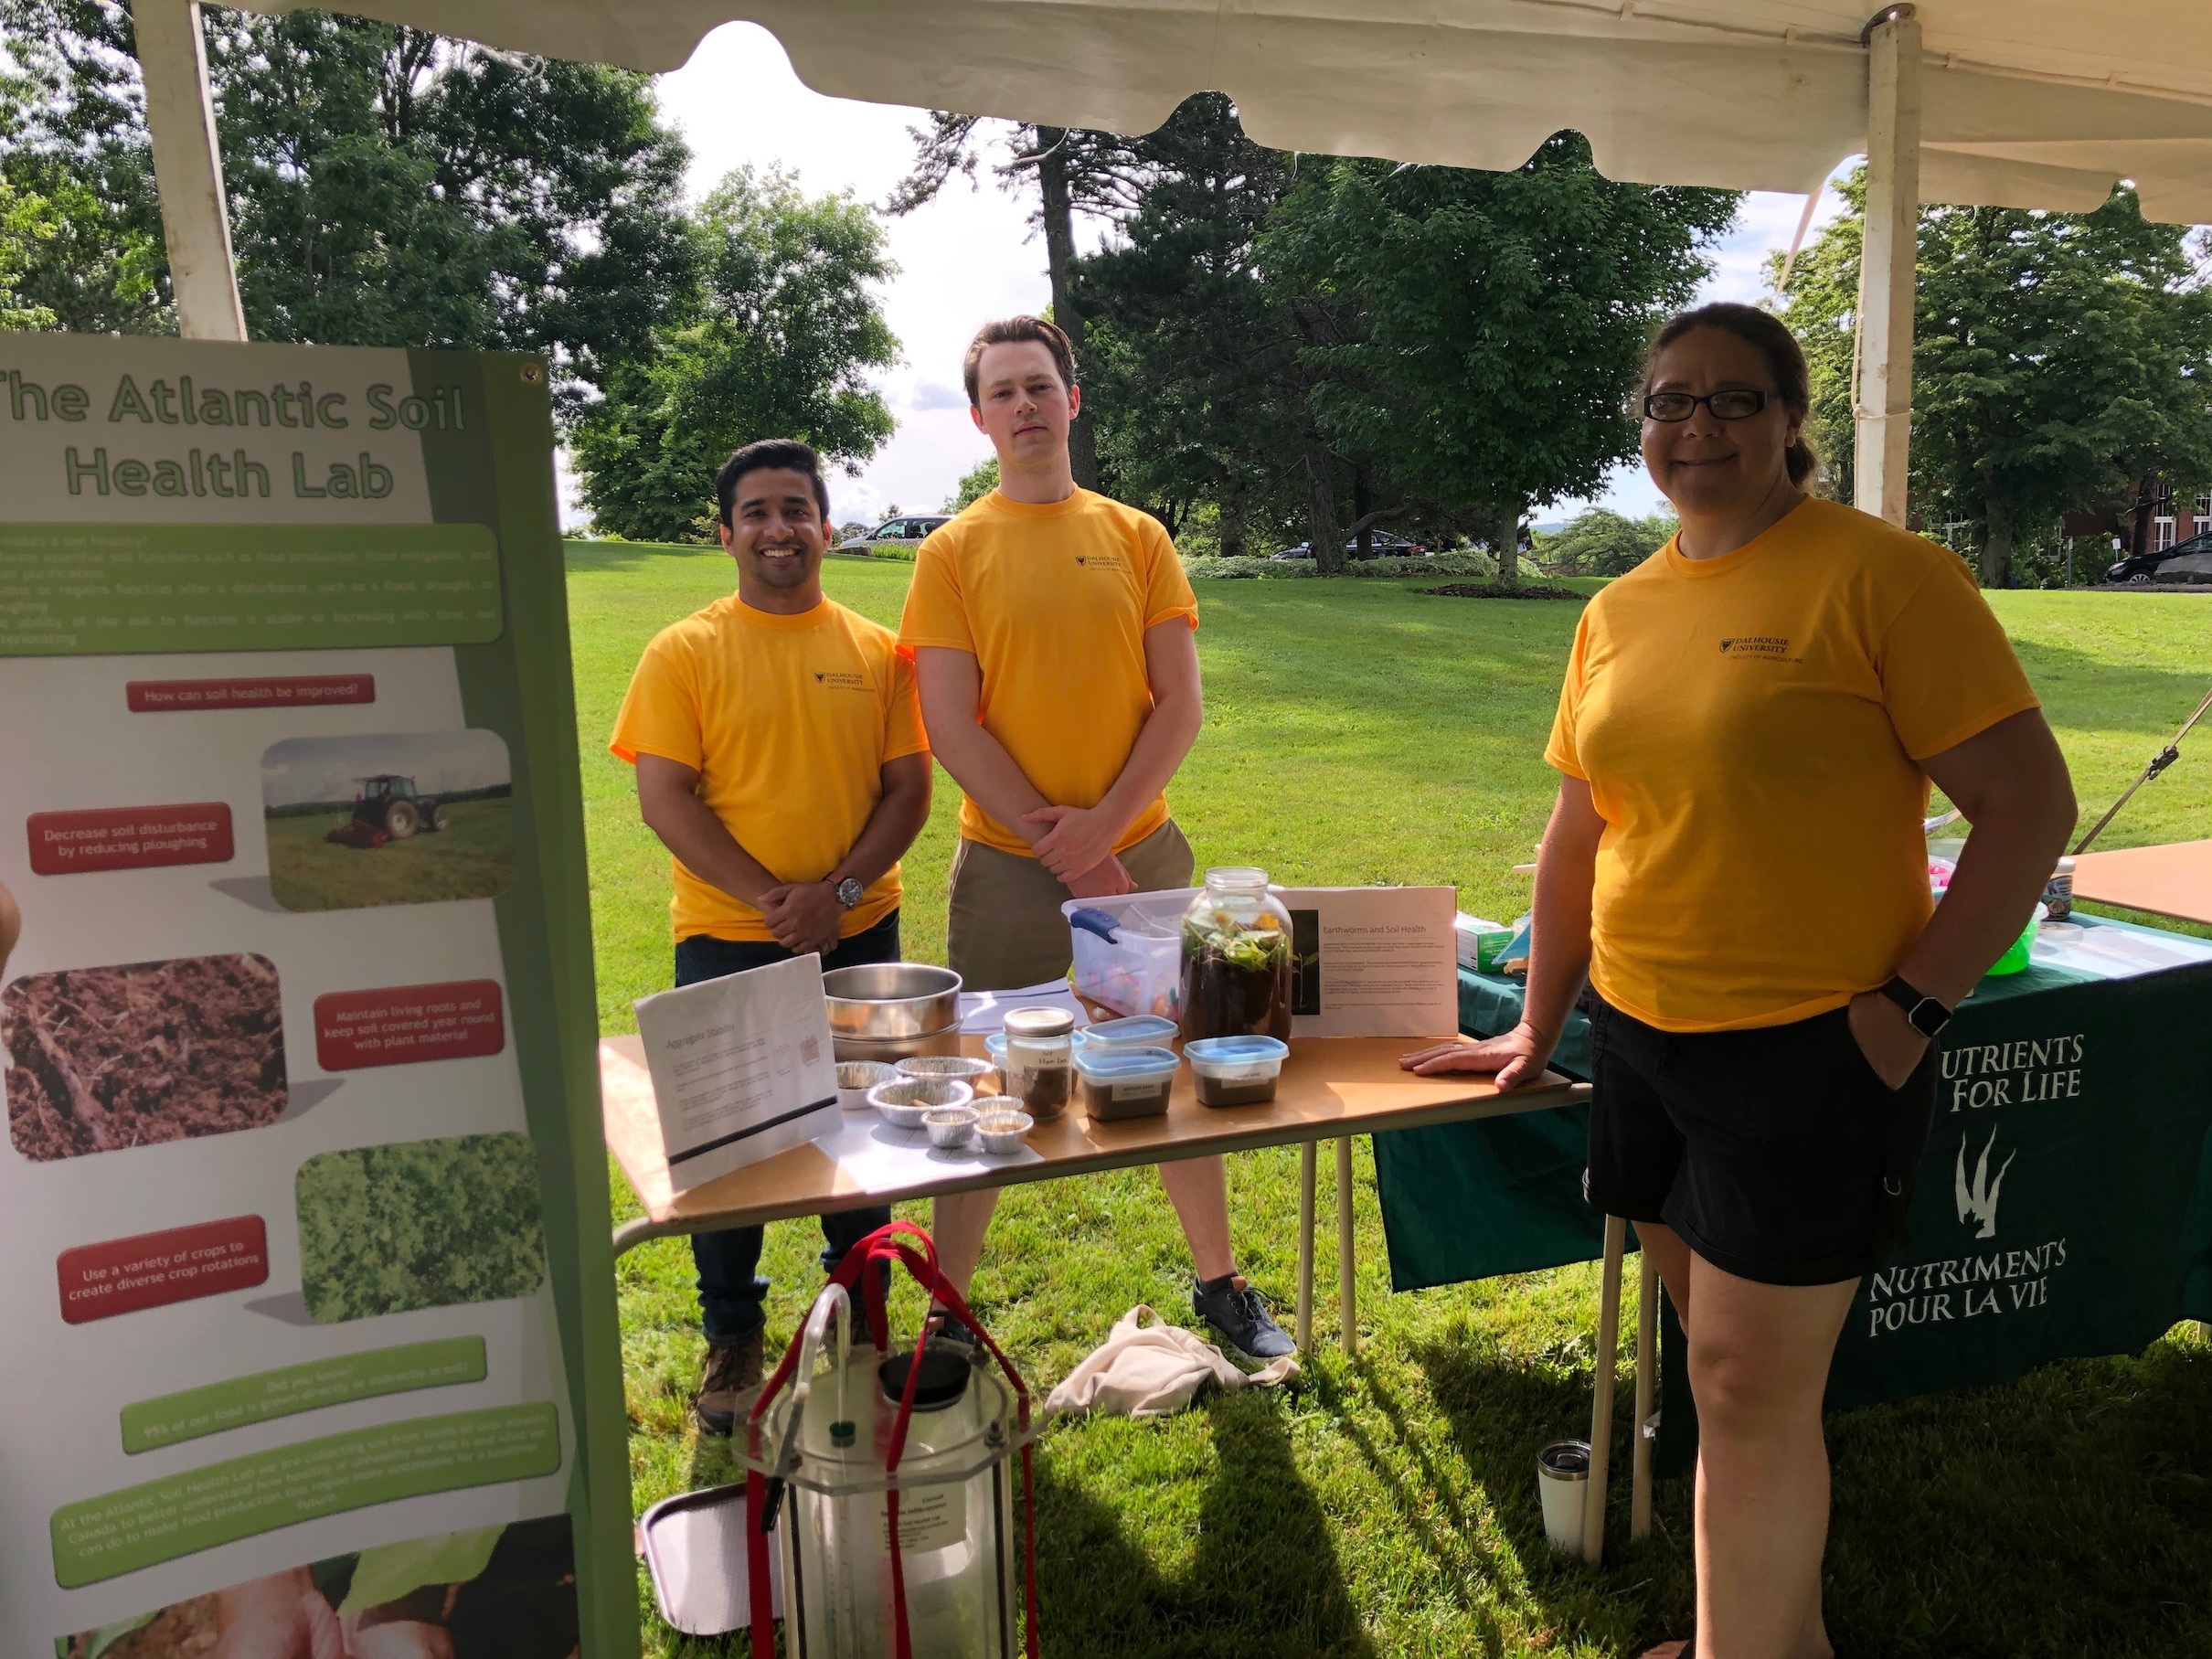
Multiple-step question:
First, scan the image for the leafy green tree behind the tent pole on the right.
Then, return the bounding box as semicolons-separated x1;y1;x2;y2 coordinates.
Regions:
1783;177;2212;586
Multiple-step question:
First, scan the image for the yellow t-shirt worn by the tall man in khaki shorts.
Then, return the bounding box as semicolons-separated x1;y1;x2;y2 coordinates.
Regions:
899;489;1199;856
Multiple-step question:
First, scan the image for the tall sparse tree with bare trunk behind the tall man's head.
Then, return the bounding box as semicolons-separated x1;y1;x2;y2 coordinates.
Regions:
885;111;1137;489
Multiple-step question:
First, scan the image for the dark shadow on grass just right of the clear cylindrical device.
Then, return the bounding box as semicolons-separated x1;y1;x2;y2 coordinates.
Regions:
1037;1391;1376;1659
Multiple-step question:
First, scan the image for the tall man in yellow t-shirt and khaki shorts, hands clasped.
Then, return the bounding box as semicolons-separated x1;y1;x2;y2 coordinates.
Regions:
899;316;1294;1360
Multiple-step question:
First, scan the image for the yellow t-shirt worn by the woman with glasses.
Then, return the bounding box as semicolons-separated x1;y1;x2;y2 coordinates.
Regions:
1544;500;2037;1031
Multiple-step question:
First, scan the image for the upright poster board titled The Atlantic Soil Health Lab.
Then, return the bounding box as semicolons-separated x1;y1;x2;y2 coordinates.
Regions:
0;334;637;1659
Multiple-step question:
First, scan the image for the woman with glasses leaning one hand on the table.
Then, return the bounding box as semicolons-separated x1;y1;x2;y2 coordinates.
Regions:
1405;305;2075;1659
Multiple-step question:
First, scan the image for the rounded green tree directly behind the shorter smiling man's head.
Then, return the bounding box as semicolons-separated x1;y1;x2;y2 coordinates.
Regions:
570;168;899;542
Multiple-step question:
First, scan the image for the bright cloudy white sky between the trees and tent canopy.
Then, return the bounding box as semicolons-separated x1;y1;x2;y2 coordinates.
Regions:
570;25;1836;535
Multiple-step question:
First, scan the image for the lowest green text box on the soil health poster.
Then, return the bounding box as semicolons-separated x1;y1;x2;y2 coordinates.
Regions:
51;1402;559;1590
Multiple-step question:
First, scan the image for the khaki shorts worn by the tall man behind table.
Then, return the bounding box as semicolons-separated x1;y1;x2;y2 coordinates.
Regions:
944;818;1195;991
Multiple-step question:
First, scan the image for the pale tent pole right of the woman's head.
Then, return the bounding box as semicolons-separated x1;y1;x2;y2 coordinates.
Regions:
1854;5;1920;526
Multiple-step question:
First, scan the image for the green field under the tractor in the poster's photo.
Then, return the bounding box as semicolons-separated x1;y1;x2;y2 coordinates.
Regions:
265;799;516;909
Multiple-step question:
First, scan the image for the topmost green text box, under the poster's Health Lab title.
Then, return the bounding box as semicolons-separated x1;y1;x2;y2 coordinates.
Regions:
0;525;500;657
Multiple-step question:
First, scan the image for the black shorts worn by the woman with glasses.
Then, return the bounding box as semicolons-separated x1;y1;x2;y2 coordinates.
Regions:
1584;994;1936;1285
